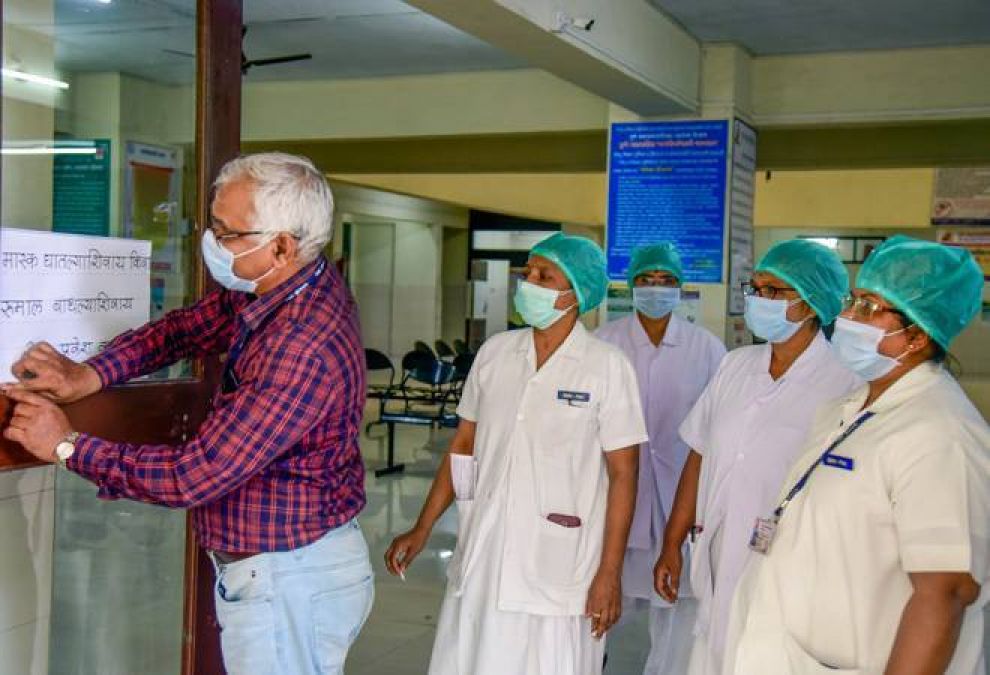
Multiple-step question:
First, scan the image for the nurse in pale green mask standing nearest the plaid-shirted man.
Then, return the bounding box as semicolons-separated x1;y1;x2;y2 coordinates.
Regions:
385;234;647;675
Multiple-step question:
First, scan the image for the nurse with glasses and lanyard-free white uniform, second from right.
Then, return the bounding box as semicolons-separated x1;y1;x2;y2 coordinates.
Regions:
654;239;860;675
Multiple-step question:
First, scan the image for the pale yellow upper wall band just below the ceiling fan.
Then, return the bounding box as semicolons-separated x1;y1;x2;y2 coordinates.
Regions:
241;70;608;141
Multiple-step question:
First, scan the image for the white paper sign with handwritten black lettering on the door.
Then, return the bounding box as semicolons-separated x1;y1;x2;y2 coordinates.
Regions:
0;228;151;381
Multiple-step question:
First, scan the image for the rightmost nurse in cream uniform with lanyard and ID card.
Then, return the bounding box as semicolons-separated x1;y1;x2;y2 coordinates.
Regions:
725;236;990;675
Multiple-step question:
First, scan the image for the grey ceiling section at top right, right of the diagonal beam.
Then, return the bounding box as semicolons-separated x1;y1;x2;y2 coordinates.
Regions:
645;0;990;56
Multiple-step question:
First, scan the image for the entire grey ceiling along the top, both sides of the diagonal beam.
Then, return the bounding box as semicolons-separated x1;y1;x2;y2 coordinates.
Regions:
4;0;990;84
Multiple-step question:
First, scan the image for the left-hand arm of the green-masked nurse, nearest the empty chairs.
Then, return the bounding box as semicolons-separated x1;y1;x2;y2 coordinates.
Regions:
385;418;477;576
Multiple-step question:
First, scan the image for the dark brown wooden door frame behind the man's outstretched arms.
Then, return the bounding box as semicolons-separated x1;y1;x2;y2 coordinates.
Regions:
0;0;243;675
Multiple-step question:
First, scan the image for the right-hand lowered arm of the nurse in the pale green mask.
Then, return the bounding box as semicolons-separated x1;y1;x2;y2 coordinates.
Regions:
585;445;639;637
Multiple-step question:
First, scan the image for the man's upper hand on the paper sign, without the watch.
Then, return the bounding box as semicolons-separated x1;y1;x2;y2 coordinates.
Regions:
10;342;103;403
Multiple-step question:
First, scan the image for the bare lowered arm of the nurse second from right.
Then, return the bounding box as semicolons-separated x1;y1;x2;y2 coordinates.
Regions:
653;450;702;602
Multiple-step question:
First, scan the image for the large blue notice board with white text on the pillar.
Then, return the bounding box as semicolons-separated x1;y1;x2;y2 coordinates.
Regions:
606;120;729;283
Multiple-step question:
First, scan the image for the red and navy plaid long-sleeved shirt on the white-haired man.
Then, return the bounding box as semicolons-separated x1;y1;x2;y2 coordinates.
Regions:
67;258;365;553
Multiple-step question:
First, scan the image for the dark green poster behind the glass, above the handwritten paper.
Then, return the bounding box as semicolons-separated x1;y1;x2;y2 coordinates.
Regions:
52;138;110;237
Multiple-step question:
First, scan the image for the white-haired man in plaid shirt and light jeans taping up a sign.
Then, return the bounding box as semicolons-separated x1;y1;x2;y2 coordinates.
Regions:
4;153;373;675
